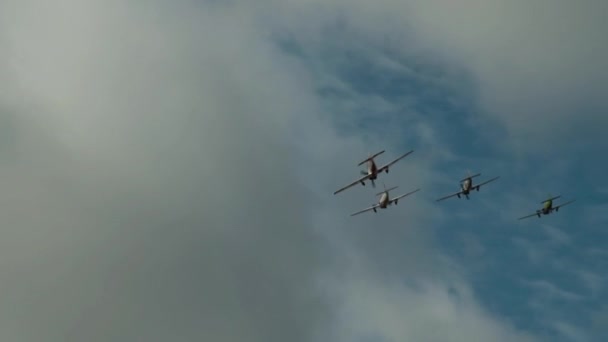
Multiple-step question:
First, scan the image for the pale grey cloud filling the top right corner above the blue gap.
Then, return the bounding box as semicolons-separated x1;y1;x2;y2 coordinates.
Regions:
274;0;608;152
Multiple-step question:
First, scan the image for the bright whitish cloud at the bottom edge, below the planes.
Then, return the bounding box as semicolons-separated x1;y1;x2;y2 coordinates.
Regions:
326;251;537;341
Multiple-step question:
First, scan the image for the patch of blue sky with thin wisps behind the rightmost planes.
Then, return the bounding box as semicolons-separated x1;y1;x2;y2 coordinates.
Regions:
280;8;608;341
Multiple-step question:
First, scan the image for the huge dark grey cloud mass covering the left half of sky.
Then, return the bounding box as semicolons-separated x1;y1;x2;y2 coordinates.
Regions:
0;1;326;341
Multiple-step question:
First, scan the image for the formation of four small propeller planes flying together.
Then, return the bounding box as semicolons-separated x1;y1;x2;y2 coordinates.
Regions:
334;150;575;220
